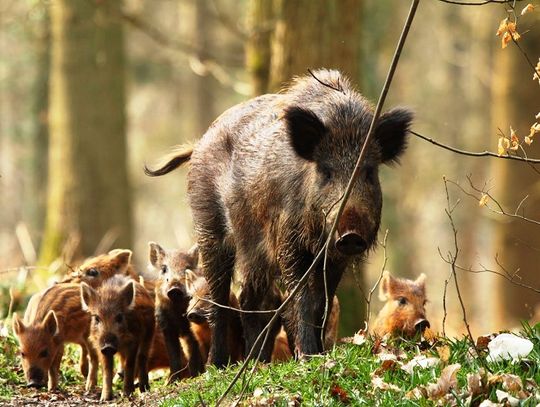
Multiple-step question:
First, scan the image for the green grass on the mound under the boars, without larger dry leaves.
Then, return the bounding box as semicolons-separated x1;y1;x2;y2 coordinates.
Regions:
0;324;540;407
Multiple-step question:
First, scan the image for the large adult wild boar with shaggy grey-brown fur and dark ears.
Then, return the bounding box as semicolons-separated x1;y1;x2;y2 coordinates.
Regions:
146;70;412;366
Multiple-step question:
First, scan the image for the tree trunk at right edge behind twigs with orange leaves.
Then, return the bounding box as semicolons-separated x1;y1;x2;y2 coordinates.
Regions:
491;19;540;328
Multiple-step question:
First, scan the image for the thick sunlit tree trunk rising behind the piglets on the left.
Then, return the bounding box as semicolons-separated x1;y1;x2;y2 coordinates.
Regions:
41;0;132;263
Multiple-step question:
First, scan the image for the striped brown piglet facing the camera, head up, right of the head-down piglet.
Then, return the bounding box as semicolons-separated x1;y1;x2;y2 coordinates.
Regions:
80;276;155;401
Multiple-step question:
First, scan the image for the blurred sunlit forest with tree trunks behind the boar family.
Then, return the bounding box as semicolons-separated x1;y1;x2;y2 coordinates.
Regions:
0;0;540;335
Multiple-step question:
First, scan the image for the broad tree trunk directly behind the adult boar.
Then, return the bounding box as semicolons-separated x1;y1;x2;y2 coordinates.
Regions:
263;0;365;335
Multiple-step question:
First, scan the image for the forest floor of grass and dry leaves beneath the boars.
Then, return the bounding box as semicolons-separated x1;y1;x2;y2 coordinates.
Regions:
0;324;540;407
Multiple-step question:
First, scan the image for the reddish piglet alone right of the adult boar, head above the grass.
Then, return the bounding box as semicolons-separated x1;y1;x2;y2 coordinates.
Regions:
373;271;430;338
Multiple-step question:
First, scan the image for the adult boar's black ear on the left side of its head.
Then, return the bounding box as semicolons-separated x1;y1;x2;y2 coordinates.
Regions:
283;106;326;161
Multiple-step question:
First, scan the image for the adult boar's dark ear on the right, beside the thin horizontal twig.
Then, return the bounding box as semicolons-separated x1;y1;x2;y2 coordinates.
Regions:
375;108;413;164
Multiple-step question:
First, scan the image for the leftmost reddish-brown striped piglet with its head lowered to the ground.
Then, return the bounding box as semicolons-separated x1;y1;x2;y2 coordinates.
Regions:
13;284;98;391
